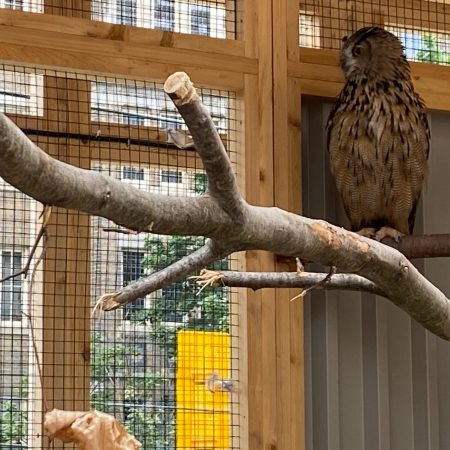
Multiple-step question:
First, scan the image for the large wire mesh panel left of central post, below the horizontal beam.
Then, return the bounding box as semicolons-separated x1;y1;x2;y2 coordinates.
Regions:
0;65;240;449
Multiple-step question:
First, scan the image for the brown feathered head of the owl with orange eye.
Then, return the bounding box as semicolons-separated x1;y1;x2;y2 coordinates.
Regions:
341;27;409;79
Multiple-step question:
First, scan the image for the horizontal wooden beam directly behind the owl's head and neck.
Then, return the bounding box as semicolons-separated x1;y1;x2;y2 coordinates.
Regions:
296;48;450;111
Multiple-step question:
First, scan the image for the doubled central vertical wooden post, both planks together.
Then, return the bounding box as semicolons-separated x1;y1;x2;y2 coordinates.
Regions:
244;0;304;450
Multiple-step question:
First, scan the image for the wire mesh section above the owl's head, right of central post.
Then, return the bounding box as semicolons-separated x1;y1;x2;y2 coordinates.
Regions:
299;0;450;65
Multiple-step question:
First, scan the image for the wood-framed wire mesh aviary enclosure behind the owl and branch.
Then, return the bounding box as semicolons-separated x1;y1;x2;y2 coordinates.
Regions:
0;0;450;450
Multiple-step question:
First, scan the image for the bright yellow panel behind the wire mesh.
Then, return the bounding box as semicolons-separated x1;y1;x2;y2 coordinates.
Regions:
176;331;230;449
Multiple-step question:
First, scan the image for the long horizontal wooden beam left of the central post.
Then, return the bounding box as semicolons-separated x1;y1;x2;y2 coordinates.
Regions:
0;9;253;90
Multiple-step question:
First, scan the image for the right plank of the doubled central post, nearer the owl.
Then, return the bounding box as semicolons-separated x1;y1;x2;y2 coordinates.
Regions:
272;0;305;450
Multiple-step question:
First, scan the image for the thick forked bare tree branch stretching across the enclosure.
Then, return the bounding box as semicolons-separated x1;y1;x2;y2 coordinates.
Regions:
0;73;450;340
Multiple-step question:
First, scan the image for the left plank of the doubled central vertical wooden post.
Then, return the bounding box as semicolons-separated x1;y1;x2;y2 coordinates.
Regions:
244;0;278;450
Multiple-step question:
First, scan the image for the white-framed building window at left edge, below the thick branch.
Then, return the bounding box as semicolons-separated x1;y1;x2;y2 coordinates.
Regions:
0;250;22;321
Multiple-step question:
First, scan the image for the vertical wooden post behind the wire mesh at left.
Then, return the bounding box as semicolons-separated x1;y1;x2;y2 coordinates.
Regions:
39;35;91;442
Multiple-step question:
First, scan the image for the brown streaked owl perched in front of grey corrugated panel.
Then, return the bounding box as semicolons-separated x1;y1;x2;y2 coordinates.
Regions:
327;27;430;240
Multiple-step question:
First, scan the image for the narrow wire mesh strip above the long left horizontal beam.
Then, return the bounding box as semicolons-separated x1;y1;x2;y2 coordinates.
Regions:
0;0;236;39
